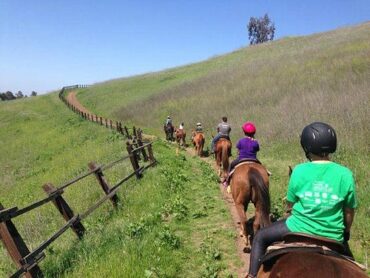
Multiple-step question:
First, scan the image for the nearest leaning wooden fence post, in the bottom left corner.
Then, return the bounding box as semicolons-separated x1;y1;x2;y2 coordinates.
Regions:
0;203;43;278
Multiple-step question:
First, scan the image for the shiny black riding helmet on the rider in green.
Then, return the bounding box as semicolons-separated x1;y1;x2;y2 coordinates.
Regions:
301;122;337;159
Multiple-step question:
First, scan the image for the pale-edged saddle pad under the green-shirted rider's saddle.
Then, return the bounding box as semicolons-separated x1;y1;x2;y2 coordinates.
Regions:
261;242;366;270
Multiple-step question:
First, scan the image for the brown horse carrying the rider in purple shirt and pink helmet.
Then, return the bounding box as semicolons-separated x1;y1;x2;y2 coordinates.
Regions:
230;161;271;252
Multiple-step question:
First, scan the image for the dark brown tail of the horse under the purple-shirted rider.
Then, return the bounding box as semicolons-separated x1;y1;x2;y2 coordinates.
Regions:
248;168;271;228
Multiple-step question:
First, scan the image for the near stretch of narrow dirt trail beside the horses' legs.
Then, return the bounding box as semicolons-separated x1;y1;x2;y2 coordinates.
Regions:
186;147;250;277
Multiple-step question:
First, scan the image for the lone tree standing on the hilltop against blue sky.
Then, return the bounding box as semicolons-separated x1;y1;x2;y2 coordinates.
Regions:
247;14;275;44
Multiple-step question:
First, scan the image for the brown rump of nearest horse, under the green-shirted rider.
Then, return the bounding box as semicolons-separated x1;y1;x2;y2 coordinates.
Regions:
257;252;368;278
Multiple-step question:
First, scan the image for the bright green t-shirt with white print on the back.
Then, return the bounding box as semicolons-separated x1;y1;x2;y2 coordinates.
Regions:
286;162;357;242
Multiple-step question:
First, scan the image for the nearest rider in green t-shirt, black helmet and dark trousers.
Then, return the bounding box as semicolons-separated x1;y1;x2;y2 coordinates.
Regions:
247;122;357;277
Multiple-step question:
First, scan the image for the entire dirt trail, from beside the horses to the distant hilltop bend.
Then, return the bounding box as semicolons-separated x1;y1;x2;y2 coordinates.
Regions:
67;92;249;277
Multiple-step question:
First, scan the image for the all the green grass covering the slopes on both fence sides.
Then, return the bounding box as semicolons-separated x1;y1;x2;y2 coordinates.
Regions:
0;23;370;277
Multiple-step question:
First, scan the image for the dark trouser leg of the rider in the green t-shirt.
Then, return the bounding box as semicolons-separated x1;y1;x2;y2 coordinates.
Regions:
249;219;290;277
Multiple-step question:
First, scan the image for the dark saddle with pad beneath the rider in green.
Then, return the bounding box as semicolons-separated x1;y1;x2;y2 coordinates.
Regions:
261;233;366;270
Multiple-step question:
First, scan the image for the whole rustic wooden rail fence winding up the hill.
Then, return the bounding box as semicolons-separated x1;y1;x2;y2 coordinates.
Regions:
0;85;156;277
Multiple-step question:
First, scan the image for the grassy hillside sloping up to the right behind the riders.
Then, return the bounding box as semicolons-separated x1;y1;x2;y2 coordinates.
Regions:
78;22;370;261
